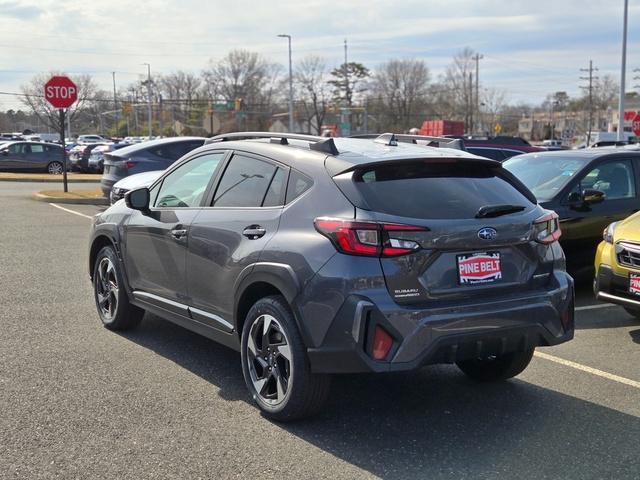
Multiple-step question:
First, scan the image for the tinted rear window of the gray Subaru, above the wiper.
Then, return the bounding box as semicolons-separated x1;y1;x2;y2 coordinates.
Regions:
354;162;533;219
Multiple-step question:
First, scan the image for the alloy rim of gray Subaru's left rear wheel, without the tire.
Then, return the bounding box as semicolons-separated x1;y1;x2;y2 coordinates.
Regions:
247;314;293;405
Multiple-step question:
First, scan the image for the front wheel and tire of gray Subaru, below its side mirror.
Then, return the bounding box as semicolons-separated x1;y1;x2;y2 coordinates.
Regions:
93;246;144;330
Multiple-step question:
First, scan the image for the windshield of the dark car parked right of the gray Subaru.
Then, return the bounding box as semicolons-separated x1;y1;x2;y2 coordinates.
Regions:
502;154;590;202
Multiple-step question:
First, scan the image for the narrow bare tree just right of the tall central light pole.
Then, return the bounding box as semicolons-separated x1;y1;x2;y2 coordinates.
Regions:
294;55;330;135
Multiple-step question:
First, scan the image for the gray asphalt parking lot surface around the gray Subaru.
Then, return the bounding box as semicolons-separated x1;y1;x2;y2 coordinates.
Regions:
0;183;640;479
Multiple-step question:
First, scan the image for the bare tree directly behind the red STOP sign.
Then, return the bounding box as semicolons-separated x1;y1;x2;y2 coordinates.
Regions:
20;72;106;131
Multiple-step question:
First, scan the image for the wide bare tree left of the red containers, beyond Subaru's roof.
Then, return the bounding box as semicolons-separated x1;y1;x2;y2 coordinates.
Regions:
371;60;429;132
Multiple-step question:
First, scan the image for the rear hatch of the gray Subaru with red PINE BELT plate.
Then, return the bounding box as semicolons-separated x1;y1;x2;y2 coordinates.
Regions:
337;159;559;305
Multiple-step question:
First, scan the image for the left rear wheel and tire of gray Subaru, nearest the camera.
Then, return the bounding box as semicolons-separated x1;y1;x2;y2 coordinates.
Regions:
241;295;331;422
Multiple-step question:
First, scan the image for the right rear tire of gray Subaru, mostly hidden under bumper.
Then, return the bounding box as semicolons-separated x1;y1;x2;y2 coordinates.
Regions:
456;348;535;382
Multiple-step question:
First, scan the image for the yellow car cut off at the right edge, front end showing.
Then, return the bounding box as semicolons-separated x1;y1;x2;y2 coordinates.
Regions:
593;212;640;319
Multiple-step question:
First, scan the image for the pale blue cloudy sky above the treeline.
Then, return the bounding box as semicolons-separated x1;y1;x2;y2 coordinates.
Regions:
0;0;640;109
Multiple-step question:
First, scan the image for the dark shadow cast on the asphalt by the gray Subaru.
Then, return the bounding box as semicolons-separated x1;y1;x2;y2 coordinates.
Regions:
123;315;640;479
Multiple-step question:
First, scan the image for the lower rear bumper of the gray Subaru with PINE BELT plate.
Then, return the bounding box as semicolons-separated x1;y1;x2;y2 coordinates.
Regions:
307;270;574;373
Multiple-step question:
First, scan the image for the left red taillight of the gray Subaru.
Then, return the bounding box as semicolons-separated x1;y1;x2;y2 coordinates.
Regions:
314;217;428;257
